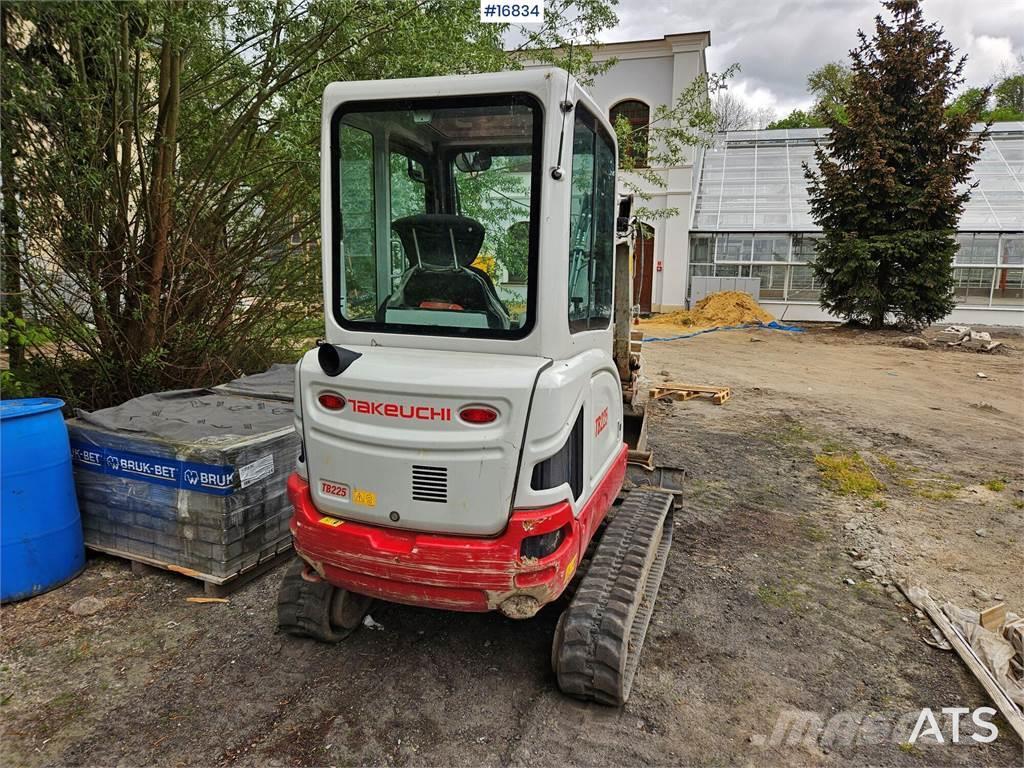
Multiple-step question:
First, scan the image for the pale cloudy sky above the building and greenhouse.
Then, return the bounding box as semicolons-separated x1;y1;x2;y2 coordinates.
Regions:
601;0;1024;117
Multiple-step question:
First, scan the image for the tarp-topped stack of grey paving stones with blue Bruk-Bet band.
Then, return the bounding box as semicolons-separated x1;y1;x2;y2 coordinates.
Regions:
68;372;299;584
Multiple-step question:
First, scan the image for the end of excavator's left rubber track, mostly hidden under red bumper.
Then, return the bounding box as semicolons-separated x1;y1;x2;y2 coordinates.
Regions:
278;559;373;643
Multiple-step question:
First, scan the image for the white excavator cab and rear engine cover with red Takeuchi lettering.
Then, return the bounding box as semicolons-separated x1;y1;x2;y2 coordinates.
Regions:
296;69;625;537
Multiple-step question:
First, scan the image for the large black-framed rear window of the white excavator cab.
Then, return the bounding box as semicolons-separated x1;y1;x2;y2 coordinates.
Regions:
332;94;542;338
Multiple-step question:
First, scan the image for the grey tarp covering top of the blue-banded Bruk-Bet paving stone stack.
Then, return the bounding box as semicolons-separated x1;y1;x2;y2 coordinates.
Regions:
77;391;292;443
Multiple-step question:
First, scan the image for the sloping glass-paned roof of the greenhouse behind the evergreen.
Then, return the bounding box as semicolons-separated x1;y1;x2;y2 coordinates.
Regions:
692;122;1024;231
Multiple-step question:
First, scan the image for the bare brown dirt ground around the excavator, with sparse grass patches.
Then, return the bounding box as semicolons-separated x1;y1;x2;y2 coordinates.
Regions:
0;329;1024;766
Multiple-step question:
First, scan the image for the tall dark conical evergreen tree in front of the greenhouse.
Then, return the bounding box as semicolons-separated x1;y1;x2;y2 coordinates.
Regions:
807;0;984;328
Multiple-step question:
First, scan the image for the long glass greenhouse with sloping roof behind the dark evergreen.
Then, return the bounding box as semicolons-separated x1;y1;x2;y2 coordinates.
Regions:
687;123;1024;313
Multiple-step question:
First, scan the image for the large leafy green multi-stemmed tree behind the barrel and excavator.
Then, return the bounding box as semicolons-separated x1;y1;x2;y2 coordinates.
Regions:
0;0;614;407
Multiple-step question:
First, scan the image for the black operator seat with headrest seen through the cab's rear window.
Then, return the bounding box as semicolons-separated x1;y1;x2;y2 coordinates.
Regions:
377;213;511;329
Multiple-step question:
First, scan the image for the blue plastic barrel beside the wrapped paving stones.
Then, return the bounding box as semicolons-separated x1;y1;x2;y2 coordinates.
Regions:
0;397;85;602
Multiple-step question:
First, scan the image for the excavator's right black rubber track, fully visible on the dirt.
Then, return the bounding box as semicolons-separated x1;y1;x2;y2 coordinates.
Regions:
552;489;672;707
